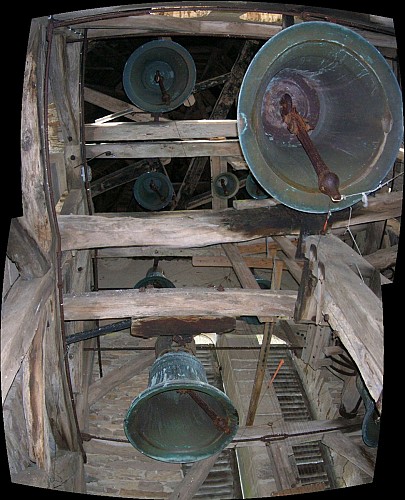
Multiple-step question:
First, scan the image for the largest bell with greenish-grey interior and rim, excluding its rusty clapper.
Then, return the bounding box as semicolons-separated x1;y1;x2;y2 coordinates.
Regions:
237;21;403;213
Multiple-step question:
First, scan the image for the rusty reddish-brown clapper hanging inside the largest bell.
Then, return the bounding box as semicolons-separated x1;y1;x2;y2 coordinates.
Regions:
280;94;342;203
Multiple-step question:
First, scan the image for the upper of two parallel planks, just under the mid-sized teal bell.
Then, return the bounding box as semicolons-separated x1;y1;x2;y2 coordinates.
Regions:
85;120;238;142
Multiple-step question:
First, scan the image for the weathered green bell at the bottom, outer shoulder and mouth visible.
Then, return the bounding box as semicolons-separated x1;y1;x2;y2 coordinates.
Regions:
124;351;239;463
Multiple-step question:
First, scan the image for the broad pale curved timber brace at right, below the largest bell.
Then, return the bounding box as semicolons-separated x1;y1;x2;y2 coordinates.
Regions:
306;235;384;401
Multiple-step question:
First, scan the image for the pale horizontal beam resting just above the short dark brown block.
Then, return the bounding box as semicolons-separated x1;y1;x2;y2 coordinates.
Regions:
64;288;297;321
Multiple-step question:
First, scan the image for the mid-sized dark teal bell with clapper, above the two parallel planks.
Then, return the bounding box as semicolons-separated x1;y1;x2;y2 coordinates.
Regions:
123;40;196;113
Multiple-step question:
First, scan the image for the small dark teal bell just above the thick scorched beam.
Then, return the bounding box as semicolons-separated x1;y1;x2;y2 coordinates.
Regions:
133;172;174;211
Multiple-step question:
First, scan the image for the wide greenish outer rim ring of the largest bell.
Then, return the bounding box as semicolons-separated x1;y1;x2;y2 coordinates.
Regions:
237;21;403;213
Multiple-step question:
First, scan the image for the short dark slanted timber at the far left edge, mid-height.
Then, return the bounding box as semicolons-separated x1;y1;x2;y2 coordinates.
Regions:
7;217;50;279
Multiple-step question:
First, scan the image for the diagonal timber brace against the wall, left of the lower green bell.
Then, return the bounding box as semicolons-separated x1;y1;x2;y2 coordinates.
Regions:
88;352;155;406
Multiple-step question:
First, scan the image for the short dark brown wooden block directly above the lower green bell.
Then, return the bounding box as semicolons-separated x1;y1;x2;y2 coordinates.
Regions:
131;316;236;338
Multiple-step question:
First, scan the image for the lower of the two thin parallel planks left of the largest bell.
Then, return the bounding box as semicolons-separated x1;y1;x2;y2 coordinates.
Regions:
86;139;242;158
